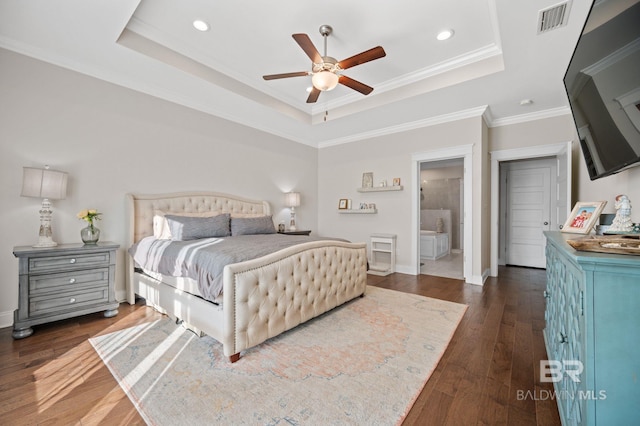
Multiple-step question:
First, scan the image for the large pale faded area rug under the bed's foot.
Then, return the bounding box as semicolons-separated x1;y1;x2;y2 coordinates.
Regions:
90;286;467;425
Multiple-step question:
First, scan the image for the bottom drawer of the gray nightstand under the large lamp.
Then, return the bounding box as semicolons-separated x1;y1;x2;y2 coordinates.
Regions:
29;286;109;317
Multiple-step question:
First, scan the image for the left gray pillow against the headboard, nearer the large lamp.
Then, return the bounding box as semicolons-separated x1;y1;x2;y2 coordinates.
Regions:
165;213;231;241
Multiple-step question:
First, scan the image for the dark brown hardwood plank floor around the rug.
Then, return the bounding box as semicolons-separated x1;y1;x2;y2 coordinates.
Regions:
0;267;560;426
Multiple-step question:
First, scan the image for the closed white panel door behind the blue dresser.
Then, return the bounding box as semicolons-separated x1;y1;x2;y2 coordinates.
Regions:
505;159;556;268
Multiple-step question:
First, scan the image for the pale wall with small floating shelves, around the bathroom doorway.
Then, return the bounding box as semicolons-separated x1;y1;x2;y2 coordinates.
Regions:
318;117;482;273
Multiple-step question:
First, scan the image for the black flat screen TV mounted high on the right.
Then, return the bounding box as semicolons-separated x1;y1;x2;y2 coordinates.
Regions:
564;0;640;180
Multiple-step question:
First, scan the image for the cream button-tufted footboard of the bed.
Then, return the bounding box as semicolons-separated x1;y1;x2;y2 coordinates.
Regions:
223;241;367;356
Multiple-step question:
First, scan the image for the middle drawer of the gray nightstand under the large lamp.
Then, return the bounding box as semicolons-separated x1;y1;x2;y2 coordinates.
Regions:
29;268;109;296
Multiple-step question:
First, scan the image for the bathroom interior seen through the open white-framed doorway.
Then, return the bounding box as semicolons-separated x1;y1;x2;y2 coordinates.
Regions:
420;159;464;279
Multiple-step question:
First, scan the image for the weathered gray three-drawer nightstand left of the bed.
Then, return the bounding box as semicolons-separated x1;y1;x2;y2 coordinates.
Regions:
13;242;120;339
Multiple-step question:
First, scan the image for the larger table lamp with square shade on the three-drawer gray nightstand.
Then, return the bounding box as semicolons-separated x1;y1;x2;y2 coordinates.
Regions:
20;166;67;247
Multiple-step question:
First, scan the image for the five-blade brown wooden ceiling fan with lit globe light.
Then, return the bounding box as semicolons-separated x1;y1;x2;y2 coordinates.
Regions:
262;25;386;103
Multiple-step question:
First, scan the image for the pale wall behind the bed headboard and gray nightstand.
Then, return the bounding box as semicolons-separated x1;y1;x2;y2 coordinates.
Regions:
0;49;318;327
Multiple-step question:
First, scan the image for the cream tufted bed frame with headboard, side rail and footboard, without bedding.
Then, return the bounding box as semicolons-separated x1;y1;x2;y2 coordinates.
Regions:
126;192;367;362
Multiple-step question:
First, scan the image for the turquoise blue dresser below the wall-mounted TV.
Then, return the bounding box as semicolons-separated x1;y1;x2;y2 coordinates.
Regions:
540;232;640;426
